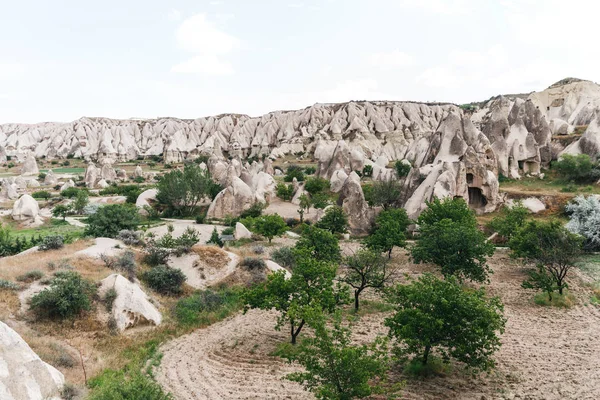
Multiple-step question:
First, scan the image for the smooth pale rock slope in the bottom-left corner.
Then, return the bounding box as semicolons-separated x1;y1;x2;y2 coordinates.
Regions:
0;321;65;400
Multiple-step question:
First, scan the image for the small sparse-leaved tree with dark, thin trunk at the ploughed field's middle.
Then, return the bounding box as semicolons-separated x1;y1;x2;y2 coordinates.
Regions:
340;250;395;311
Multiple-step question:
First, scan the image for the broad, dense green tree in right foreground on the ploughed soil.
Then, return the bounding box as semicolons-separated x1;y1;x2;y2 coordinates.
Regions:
385;274;506;370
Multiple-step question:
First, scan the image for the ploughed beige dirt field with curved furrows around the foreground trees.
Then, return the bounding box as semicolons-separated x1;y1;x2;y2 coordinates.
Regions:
156;251;600;400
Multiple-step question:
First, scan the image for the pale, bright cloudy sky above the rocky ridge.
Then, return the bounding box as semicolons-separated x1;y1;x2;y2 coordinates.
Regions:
0;0;600;123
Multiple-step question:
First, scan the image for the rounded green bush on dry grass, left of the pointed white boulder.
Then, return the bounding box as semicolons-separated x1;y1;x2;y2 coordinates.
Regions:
30;271;96;318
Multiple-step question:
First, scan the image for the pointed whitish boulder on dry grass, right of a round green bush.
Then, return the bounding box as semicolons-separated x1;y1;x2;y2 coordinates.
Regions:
99;274;162;332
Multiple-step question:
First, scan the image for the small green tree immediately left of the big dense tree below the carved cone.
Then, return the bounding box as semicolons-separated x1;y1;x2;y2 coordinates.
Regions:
365;208;410;258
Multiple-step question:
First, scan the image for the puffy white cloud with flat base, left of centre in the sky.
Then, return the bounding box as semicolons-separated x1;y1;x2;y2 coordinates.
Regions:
171;14;240;75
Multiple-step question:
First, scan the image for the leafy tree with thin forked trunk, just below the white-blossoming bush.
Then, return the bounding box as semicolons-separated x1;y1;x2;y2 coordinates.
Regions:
508;221;583;294
